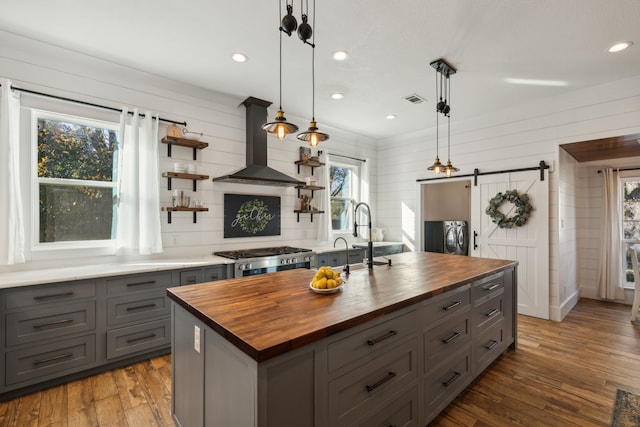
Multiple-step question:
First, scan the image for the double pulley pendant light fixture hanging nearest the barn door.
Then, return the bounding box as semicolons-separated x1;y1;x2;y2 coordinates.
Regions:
427;59;460;177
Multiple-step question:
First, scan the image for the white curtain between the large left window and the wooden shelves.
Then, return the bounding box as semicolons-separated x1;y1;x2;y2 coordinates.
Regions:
116;108;162;255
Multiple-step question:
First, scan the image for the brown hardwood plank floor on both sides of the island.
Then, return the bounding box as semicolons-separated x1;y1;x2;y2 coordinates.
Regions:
0;299;640;427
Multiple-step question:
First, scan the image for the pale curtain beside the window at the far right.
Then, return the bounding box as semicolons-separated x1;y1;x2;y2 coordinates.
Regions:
598;168;625;300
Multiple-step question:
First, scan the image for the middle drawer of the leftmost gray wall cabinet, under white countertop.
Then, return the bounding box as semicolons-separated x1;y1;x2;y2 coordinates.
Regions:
6;301;96;346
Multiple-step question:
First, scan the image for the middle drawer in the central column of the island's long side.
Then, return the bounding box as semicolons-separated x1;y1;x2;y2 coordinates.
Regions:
424;312;471;366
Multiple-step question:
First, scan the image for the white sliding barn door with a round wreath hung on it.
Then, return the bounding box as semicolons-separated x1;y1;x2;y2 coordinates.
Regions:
469;170;549;319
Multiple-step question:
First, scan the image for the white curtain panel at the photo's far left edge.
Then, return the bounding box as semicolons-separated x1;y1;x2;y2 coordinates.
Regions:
0;79;25;265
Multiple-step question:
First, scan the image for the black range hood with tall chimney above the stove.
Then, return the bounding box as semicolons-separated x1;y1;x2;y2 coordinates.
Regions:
213;96;304;186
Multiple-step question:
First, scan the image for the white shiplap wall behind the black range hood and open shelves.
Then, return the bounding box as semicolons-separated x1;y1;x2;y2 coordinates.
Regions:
0;31;376;263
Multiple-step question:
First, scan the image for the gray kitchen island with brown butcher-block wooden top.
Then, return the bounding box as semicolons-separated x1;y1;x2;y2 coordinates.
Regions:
167;252;517;427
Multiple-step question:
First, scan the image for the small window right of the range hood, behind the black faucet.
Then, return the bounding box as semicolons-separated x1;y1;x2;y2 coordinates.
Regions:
329;161;360;232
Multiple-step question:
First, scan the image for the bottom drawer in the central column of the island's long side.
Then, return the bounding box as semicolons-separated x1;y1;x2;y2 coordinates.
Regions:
424;346;472;418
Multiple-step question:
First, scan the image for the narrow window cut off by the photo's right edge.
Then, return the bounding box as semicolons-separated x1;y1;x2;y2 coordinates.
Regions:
622;177;640;287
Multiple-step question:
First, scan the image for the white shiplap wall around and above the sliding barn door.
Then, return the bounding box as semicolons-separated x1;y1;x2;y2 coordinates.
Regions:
377;76;640;320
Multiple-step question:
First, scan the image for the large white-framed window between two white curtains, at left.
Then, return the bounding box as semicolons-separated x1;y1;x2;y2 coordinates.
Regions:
31;110;118;247
